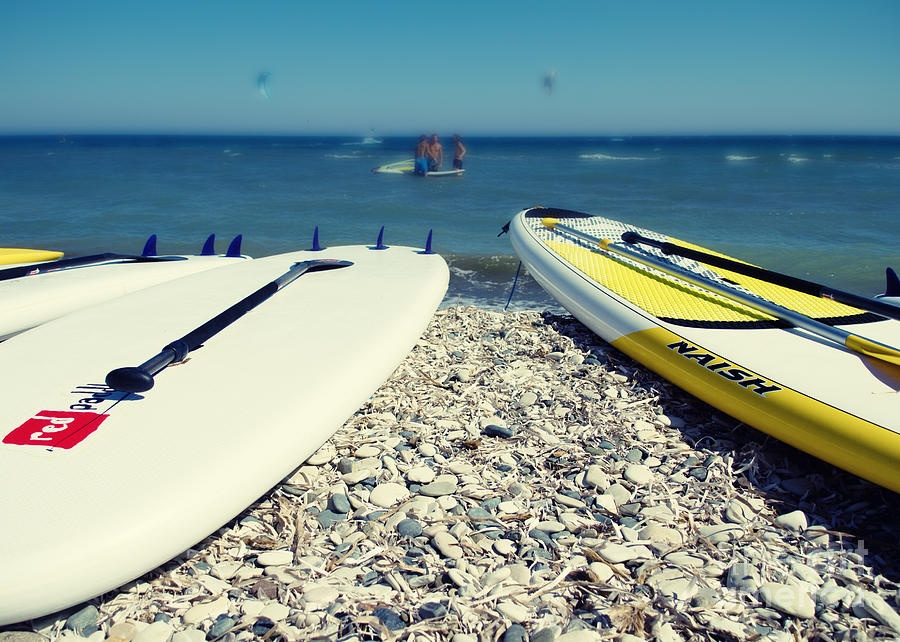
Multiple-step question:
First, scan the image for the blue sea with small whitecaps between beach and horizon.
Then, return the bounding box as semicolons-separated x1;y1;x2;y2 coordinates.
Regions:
0;132;900;310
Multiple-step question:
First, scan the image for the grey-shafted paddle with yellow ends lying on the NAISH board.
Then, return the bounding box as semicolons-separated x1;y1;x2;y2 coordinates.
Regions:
541;218;900;365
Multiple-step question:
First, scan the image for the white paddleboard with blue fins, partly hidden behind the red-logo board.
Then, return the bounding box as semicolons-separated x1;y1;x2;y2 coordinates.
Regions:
0;236;249;340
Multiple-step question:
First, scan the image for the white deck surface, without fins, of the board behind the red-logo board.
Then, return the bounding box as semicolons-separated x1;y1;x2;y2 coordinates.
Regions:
0;255;249;339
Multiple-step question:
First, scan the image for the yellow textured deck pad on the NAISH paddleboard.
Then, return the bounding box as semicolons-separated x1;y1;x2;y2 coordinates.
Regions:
545;239;862;323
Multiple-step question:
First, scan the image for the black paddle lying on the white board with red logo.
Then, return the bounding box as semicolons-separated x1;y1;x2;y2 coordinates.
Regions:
106;259;353;392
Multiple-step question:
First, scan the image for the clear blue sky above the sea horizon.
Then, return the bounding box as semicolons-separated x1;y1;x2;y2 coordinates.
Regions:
0;0;900;135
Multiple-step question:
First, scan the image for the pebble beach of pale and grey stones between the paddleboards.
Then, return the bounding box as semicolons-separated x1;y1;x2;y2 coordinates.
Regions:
0;307;900;642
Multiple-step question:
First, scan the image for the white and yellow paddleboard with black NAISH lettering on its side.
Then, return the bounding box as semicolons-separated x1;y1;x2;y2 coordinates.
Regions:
510;208;900;492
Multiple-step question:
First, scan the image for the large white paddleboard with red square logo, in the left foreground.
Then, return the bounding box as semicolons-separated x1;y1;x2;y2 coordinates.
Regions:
0;246;449;624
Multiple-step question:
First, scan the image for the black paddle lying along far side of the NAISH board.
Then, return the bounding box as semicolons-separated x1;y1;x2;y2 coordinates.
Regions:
622;232;900;319
